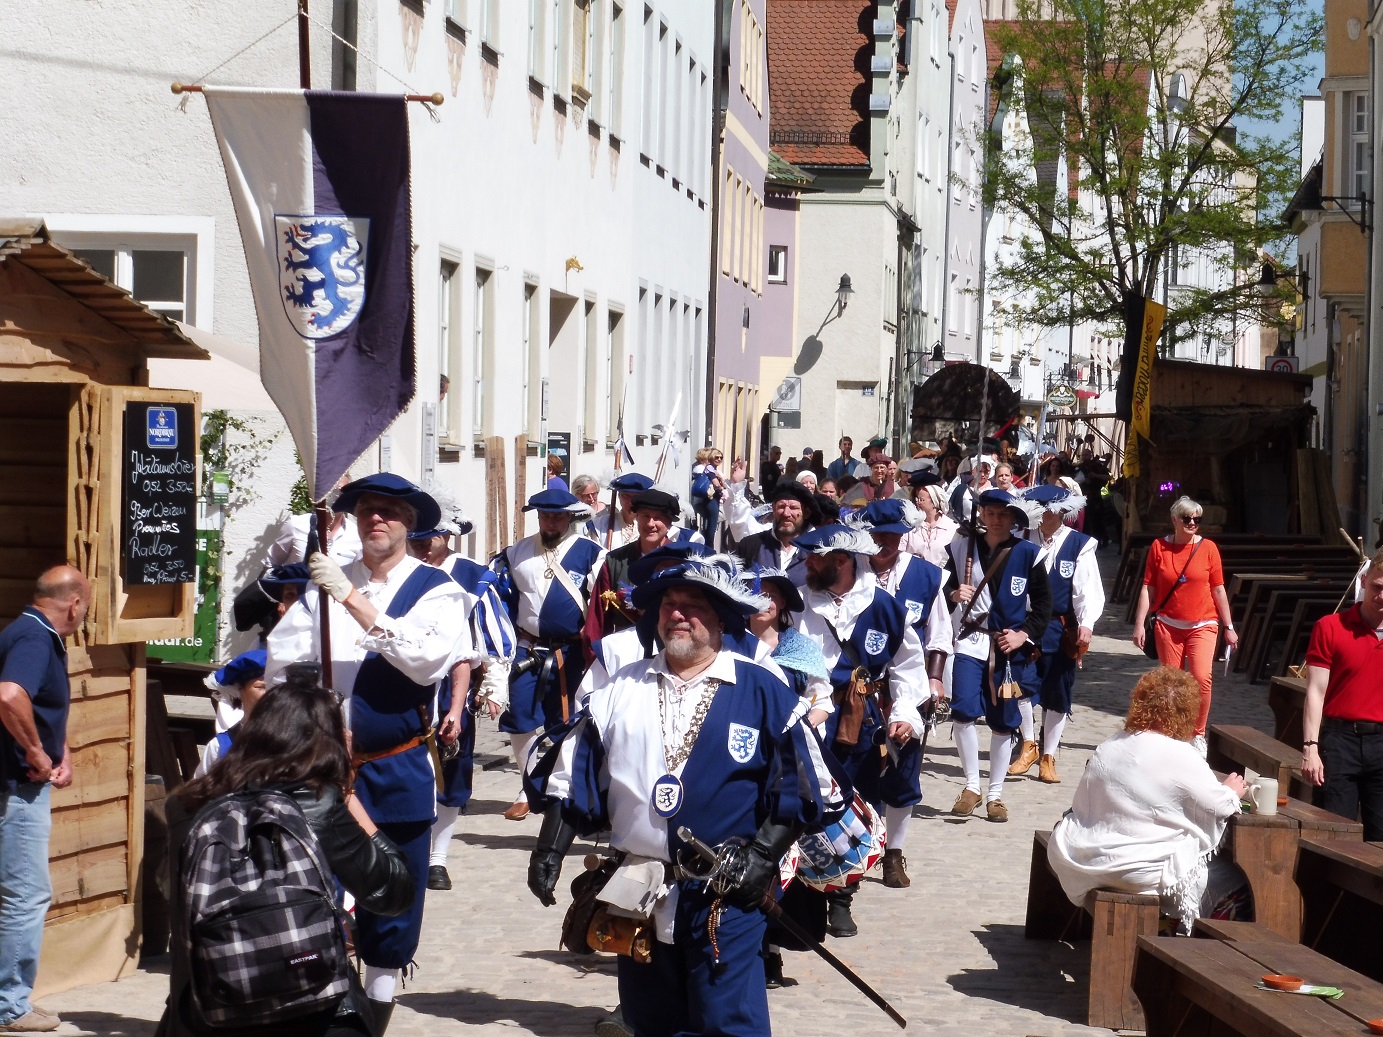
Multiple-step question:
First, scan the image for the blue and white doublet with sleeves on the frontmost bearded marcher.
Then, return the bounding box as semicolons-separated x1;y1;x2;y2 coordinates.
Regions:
528;651;845;943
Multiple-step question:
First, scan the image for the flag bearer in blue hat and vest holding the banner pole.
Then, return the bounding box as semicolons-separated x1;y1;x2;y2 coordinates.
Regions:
266;473;477;1013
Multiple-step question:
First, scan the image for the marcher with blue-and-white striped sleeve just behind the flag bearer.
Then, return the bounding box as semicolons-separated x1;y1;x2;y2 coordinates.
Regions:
408;489;516;890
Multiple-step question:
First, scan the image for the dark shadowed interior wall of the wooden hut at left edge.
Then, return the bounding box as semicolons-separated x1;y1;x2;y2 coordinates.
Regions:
0;383;72;626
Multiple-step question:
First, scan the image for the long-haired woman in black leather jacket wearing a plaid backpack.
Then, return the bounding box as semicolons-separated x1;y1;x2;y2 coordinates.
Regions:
158;678;415;1037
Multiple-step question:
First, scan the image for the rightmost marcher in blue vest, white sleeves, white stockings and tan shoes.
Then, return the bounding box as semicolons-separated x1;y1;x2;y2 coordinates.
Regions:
1008;485;1105;784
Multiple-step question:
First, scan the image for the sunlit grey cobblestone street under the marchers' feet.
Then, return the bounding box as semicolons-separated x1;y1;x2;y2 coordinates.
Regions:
41;554;1271;1037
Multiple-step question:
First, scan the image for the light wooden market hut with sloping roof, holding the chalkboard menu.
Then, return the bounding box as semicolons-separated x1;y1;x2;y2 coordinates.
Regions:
0;221;207;996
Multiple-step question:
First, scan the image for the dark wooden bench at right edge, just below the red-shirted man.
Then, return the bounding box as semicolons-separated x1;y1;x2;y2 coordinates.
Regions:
1296;839;1383;980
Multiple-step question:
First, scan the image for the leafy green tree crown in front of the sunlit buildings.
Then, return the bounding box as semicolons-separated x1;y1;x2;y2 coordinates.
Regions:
985;0;1324;366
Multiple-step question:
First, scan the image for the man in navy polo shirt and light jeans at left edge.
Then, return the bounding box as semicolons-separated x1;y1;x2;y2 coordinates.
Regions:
0;566;91;1033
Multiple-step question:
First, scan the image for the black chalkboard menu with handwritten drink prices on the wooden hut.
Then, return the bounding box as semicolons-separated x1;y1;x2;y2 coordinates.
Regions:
120;401;198;585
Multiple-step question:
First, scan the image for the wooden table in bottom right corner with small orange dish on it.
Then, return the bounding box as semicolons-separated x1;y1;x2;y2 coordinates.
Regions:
1133;936;1383;1037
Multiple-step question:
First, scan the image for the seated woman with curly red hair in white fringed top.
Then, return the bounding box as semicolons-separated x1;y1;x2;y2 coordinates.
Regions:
1047;666;1246;933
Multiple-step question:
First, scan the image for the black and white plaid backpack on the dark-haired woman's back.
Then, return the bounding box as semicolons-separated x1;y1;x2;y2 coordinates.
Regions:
174;791;350;1027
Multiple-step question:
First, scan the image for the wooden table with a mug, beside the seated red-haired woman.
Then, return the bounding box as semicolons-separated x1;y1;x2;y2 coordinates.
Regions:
1228;799;1364;940
